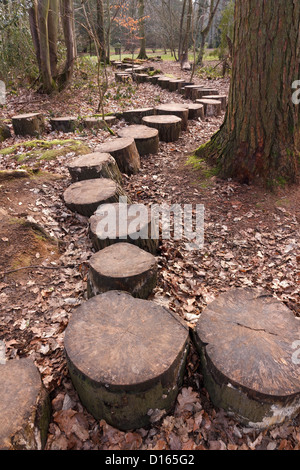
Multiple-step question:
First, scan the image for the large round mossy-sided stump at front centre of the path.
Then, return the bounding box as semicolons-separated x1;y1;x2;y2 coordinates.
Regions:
65;291;189;431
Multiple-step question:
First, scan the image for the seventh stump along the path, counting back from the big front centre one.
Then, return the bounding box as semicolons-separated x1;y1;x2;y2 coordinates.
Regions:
118;124;159;157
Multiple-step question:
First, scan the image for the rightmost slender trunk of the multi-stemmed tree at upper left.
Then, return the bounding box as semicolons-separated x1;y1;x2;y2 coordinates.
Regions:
59;0;76;89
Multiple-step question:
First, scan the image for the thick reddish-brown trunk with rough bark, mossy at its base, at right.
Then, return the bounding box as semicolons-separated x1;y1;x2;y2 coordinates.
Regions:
196;0;300;186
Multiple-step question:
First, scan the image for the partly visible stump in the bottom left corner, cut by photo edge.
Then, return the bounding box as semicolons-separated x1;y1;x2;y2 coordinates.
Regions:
0;359;51;450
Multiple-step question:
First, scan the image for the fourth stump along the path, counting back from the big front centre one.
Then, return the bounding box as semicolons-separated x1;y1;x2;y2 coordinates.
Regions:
64;178;126;217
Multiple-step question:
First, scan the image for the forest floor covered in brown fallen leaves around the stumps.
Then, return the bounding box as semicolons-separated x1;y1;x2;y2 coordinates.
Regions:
0;62;300;450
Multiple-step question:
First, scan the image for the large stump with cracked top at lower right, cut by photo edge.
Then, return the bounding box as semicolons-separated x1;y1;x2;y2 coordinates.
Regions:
195;289;300;429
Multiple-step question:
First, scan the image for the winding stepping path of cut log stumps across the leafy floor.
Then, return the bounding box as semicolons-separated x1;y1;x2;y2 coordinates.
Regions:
4;63;300;449
